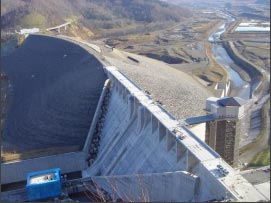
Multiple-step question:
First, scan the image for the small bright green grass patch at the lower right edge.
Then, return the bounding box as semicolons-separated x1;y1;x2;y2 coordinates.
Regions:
249;146;270;167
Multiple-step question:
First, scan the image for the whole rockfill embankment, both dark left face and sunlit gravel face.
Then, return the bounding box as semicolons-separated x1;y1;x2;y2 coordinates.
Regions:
3;33;211;150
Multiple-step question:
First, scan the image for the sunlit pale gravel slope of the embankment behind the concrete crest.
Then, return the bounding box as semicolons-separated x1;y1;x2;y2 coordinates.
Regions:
102;49;212;119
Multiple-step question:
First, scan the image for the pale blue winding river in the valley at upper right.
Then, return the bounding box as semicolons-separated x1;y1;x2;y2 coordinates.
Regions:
208;15;253;99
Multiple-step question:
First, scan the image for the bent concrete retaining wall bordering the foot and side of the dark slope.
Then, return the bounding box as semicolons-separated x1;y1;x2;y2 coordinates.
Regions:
1;80;110;184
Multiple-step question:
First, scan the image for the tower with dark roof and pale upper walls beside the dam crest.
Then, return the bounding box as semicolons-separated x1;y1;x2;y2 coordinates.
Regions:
205;97;245;167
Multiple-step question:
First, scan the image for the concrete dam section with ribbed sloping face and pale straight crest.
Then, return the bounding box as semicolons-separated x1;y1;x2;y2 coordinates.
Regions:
83;67;264;201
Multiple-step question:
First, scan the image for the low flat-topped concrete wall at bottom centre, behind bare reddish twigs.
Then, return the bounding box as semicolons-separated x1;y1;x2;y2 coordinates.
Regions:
92;171;199;202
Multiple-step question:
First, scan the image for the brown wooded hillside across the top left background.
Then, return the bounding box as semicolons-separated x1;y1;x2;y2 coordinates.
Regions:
1;0;189;38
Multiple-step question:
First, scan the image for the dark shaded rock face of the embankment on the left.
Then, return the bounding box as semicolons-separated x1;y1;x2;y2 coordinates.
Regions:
2;35;106;151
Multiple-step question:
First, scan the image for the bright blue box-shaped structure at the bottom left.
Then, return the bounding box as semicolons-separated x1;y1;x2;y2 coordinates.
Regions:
26;168;61;201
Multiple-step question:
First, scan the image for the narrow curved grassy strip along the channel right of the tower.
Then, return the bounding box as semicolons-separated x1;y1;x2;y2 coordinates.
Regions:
240;99;270;154
